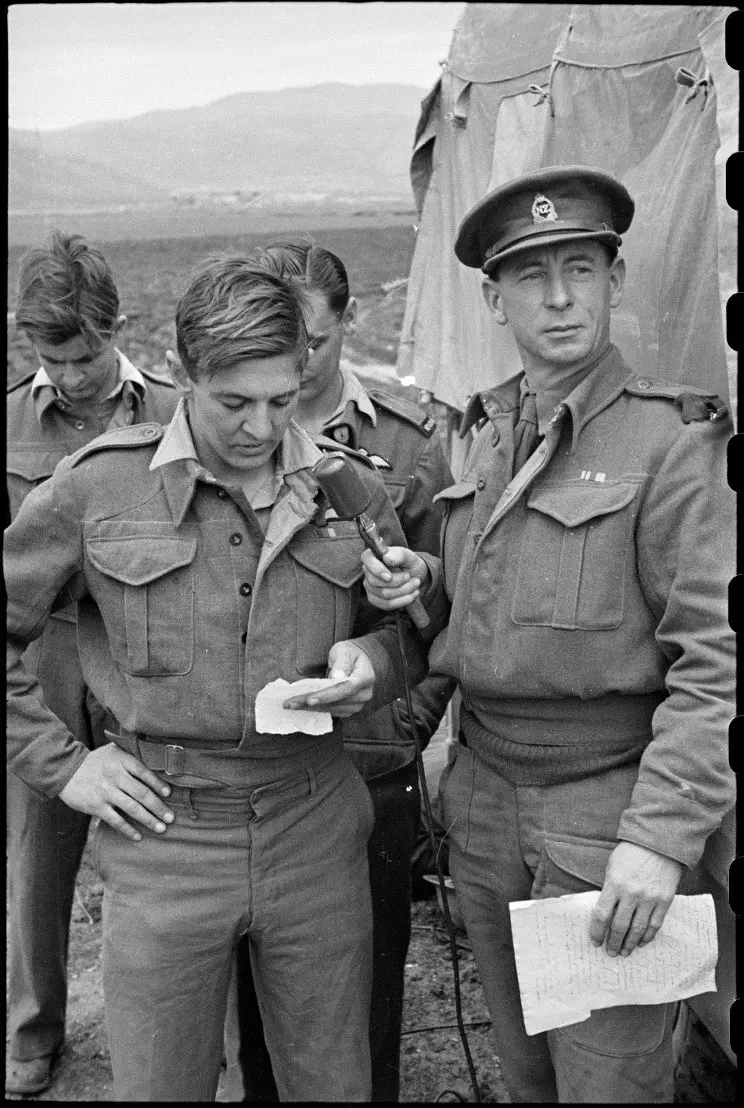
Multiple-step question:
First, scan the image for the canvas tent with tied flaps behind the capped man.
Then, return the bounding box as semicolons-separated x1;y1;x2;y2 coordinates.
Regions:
397;3;738;445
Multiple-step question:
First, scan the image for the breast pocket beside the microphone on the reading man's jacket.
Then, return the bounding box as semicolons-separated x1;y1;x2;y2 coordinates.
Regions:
288;520;364;677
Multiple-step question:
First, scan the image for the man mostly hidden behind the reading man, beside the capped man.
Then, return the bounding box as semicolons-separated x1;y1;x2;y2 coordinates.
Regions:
227;242;455;1101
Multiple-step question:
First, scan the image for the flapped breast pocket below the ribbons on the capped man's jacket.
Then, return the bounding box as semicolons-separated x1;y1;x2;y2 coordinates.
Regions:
511;481;640;630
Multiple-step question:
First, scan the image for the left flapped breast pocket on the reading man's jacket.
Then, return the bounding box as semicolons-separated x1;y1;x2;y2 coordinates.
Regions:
85;534;196;677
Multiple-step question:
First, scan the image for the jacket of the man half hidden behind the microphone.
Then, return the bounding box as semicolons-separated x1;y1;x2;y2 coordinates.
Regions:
323;389;455;781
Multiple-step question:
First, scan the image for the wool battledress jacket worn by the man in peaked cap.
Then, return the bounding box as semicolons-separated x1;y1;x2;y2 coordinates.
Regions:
416;348;735;866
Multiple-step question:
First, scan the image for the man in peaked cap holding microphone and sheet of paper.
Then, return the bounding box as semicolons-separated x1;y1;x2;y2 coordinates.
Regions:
364;166;734;1102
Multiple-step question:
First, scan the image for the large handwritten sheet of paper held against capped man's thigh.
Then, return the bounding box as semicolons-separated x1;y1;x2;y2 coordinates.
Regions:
509;892;718;1035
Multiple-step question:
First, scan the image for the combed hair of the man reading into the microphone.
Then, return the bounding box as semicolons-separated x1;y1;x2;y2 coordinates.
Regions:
175;254;307;381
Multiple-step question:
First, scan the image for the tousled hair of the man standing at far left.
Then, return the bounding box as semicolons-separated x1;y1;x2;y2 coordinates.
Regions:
16;230;119;347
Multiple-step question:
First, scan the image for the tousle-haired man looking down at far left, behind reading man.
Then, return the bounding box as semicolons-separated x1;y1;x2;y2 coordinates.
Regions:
6;232;177;1095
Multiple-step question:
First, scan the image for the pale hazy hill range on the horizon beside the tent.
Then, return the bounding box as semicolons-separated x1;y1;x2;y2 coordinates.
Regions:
9;84;427;211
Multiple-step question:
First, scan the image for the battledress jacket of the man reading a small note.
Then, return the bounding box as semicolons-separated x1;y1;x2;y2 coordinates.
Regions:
4;423;426;796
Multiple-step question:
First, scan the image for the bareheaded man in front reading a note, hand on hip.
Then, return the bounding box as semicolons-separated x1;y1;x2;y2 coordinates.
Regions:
6;256;425;1101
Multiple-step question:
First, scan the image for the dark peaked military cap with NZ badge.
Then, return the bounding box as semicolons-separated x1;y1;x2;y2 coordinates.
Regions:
455;165;635;274
